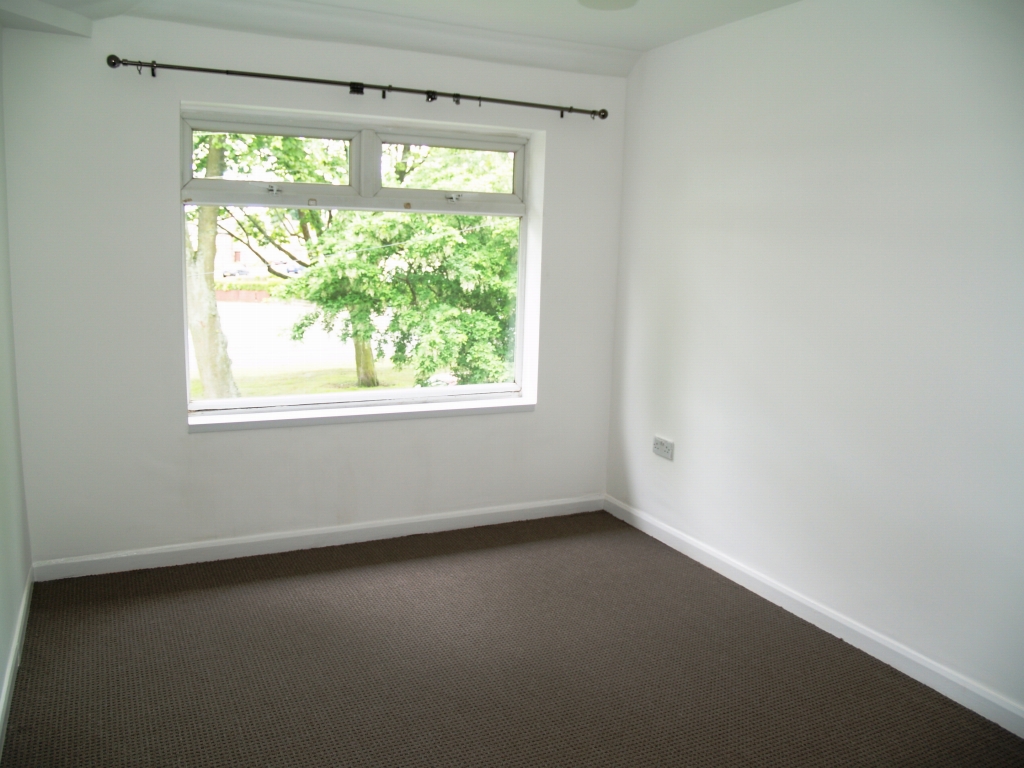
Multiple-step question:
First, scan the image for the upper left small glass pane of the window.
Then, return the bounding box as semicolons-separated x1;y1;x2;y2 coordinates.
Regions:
193;131;349;184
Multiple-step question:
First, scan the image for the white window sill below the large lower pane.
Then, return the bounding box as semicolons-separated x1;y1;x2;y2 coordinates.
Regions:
188;393;537;432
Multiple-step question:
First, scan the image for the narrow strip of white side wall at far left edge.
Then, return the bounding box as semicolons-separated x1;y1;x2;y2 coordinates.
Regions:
0;28;31;753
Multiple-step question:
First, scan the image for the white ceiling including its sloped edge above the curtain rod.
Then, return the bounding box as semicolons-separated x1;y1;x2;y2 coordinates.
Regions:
14;0;797;75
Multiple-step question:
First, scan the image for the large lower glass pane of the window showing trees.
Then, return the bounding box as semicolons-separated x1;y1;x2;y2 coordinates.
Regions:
185;206;520;400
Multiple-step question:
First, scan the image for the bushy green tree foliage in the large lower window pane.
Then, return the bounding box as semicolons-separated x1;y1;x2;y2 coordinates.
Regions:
281;212;519;385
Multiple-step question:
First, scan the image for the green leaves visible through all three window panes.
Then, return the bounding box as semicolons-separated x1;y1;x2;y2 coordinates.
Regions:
194;132;519;386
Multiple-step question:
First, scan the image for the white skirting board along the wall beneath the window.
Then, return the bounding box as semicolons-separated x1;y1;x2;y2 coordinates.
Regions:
33;495;604;582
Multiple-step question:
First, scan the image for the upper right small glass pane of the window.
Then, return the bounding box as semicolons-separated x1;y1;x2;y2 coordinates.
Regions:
381;144;515;195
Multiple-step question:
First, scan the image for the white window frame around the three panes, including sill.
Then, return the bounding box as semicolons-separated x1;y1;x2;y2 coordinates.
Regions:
180;103;544;432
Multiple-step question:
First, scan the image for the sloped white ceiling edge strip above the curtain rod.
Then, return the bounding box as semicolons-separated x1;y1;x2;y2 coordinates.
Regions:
125;0;643;77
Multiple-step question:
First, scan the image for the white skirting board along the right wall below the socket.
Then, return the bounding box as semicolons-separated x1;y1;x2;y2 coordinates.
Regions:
604;496;1024;738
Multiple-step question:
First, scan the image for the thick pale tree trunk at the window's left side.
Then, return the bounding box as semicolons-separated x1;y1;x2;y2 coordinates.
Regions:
185;136;239;399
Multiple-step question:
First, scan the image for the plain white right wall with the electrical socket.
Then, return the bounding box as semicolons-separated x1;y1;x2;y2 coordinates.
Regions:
608;0;1024;723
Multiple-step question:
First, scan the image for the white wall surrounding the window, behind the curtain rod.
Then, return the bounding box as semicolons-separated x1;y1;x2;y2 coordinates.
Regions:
3;18;626;561
